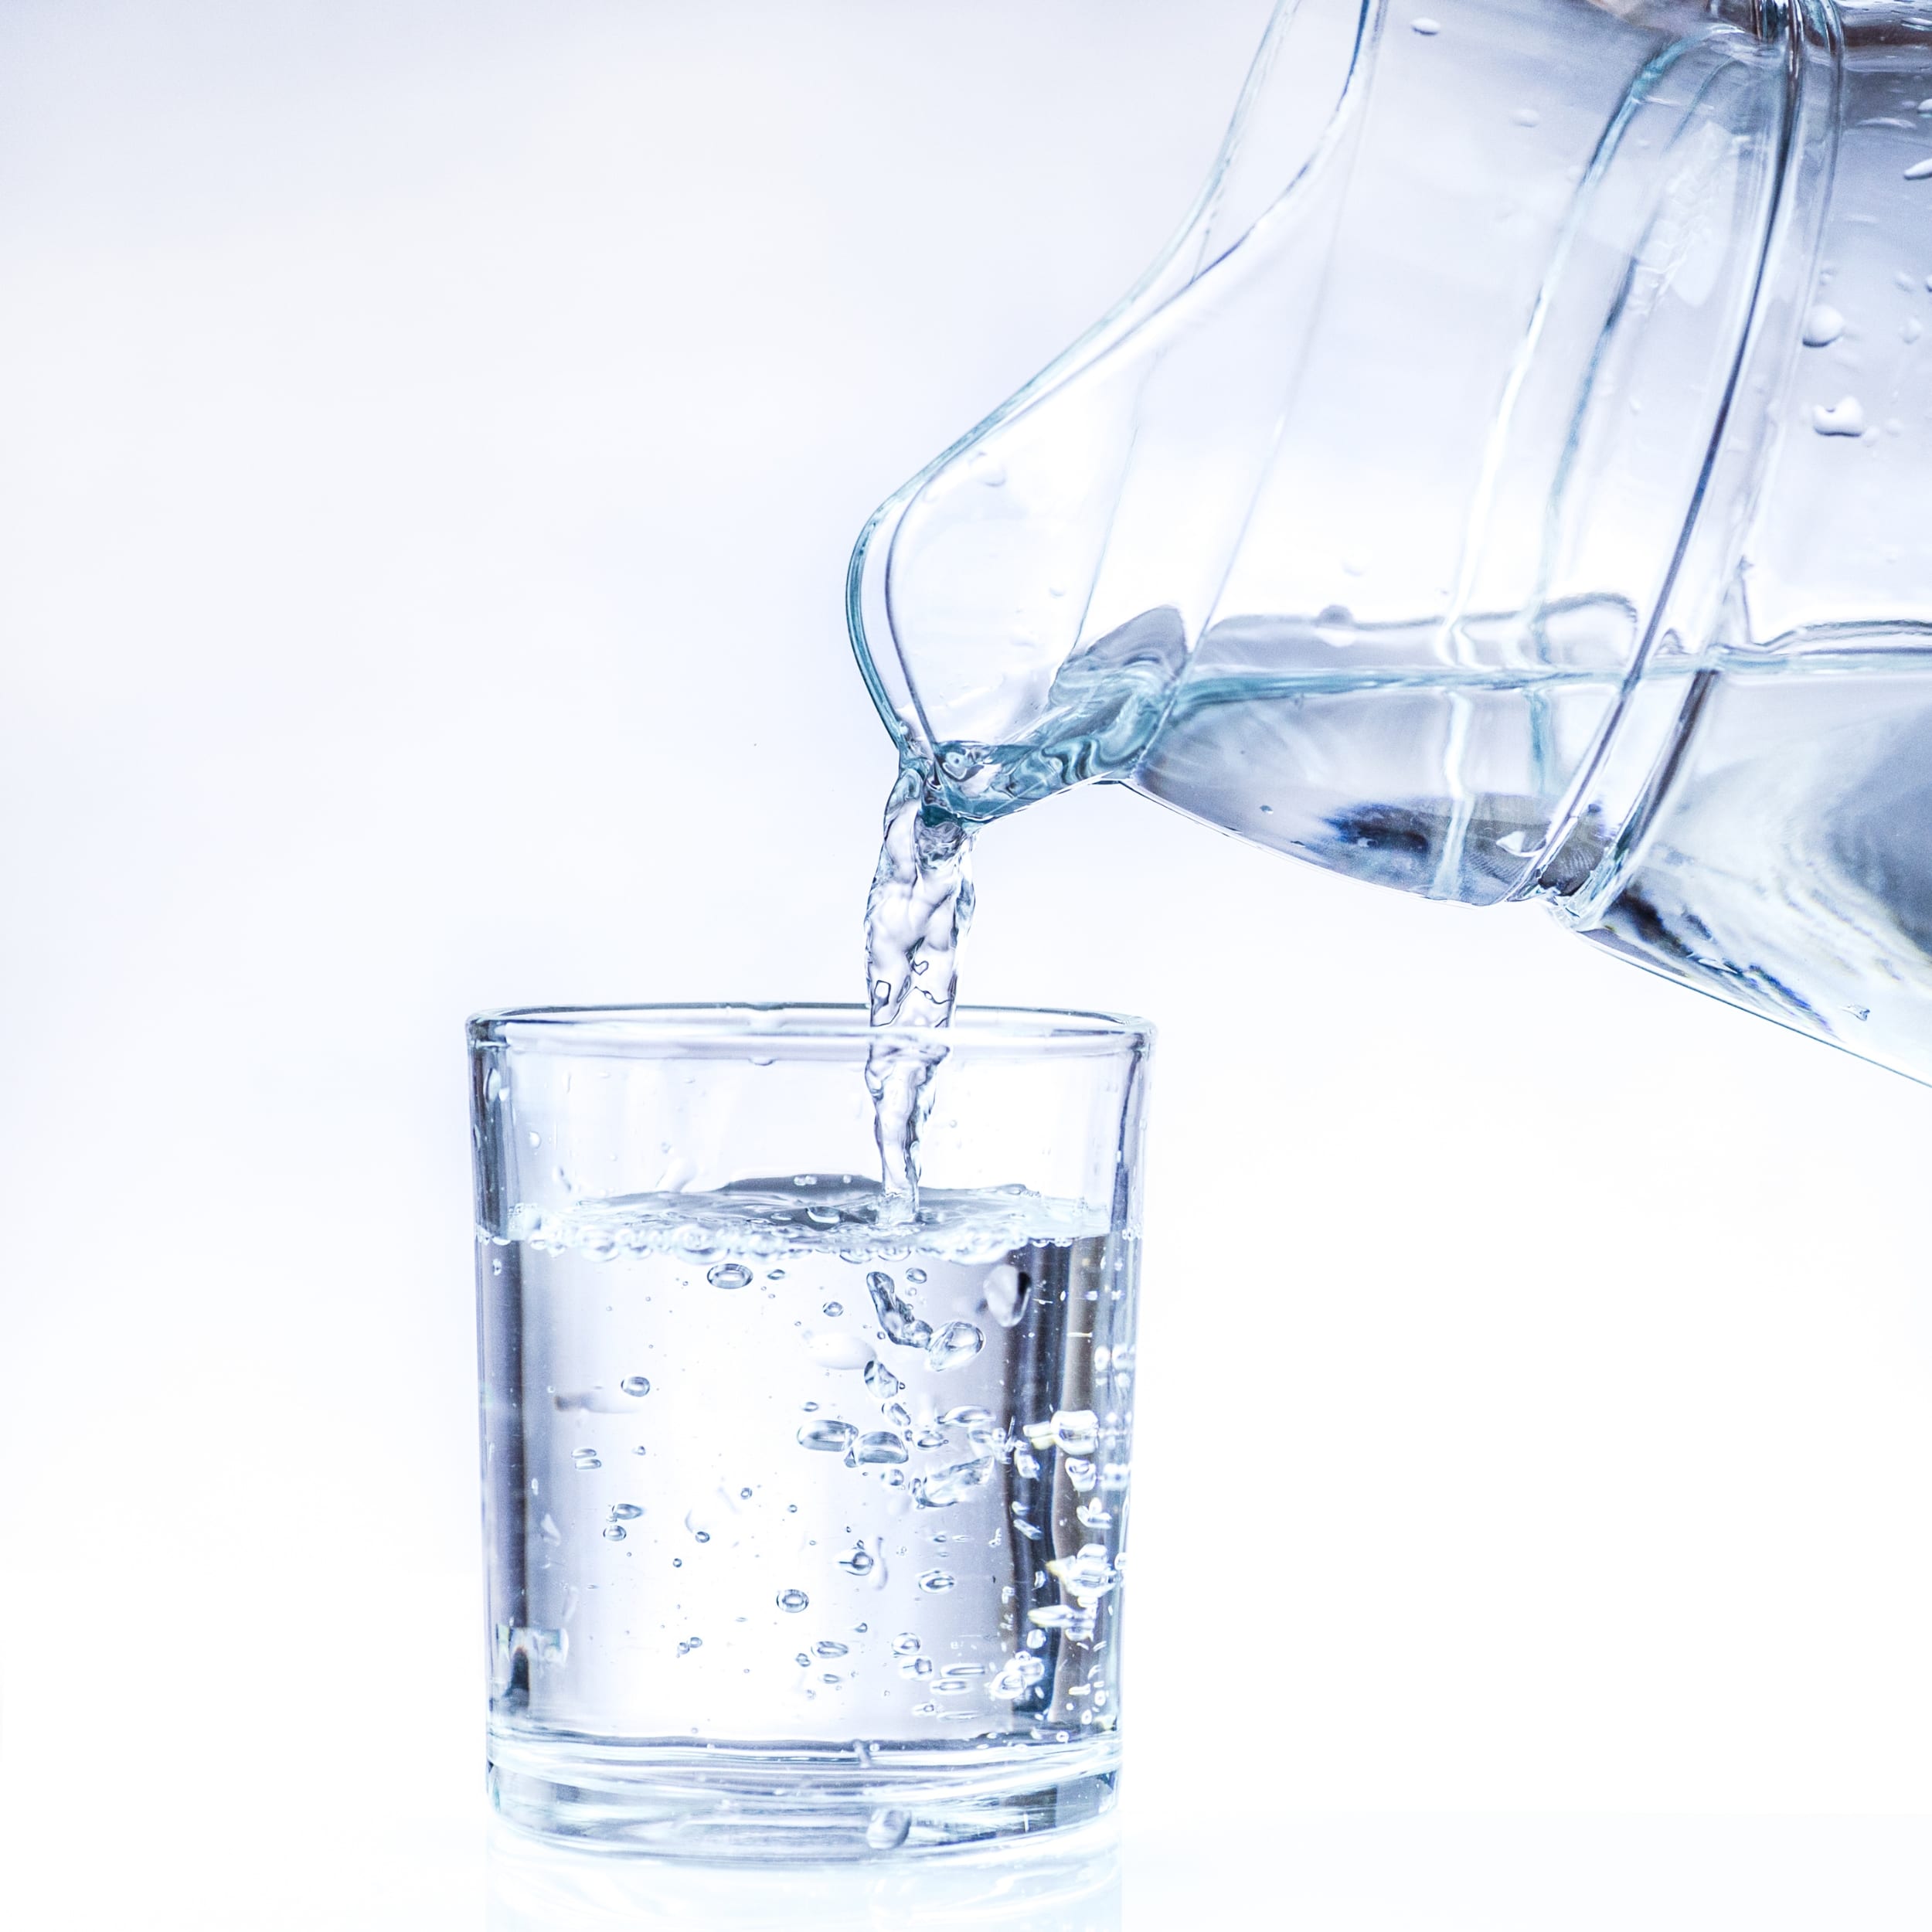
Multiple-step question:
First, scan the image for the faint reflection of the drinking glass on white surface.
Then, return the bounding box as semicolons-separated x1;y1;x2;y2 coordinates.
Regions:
487;1824;1121;1932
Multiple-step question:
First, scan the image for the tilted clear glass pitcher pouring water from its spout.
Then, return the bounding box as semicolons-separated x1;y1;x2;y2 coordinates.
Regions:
850;0;1932;1077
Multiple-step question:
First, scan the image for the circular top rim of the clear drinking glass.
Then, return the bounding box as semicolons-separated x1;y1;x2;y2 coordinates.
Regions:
468;1001;1154;1055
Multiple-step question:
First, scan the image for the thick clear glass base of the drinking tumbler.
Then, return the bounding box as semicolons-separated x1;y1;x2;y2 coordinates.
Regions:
489;1726;1121;1861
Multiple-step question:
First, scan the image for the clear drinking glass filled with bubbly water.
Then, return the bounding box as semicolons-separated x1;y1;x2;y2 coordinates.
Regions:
470;1007;1150;1859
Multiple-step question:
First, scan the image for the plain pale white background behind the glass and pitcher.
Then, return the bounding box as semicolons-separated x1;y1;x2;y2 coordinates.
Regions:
0;0;1932;1932
